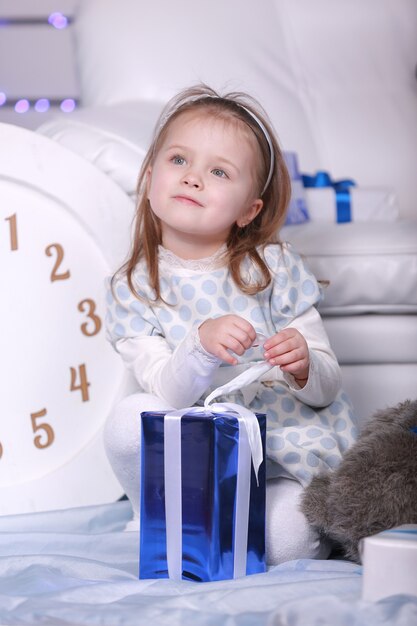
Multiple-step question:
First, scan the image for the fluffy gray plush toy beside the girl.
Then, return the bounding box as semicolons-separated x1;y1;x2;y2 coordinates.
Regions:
301;400;417;562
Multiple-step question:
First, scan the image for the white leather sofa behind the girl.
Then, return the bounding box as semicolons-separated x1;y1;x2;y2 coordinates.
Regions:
38;0;417;419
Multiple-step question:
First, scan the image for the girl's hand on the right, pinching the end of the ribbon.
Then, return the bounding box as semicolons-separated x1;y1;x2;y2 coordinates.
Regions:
264;328;310;387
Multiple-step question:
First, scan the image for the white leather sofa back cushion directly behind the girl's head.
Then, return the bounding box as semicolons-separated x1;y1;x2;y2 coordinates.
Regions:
74;0;318;170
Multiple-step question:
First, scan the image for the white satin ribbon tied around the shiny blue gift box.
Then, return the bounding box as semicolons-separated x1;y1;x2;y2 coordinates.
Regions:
164;376;266;580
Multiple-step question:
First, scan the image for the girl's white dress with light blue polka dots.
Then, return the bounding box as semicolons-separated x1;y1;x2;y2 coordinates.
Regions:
106;244;357;485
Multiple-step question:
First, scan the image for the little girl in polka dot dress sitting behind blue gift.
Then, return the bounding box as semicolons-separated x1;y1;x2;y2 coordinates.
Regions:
105;85;356;564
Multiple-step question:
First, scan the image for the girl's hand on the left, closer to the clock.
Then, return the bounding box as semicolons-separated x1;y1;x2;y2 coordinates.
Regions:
198;315;256;365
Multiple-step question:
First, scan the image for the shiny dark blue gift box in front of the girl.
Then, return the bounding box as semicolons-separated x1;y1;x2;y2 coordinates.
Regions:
139;410;266;581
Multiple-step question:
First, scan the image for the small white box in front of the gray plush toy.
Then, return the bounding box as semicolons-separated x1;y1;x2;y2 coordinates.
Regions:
362;524;417;602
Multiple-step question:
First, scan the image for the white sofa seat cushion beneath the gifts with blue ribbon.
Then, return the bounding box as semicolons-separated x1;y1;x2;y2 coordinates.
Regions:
281;220;417;315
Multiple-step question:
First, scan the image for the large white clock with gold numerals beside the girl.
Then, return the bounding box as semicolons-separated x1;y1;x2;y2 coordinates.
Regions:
0;124;133;514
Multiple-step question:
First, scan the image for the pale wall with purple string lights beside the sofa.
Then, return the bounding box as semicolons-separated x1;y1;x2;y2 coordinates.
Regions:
0;0;79;128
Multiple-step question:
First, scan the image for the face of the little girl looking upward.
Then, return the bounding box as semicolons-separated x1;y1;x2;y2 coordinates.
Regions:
148;111;262;258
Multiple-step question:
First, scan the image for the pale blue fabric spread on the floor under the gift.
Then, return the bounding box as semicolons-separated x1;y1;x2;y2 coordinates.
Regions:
0;502;417;626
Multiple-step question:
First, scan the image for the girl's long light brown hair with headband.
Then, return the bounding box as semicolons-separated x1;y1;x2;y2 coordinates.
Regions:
113;84;291;301
